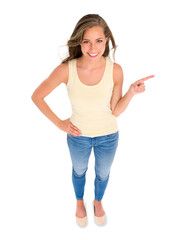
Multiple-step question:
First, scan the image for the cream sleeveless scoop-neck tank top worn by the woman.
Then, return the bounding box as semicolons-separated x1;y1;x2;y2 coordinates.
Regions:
66;57;118;137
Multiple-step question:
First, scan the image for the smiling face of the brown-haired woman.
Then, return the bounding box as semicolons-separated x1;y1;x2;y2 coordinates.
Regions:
81;26;108;60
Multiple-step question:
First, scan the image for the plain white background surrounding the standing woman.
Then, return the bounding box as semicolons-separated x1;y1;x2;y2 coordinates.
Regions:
0;0;186;240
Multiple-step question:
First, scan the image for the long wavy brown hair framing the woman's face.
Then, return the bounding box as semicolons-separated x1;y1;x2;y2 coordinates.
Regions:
61;14;117;63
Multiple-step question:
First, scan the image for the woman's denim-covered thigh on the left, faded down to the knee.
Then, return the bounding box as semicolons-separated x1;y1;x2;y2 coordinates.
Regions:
67;133;92;175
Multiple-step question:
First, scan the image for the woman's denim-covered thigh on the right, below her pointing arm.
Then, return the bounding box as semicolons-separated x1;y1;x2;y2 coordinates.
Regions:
94;131;119;179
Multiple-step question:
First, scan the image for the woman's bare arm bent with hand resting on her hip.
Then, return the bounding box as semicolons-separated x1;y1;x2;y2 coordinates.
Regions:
31;63;81;136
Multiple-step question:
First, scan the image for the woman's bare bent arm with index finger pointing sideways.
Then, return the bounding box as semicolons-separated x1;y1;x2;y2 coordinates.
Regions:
111;63;154;117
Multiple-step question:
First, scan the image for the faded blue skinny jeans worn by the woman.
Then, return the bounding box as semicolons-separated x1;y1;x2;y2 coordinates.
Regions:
67;131;119;201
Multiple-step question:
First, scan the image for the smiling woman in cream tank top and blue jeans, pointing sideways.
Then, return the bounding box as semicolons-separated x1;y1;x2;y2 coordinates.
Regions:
32;14;154;226
